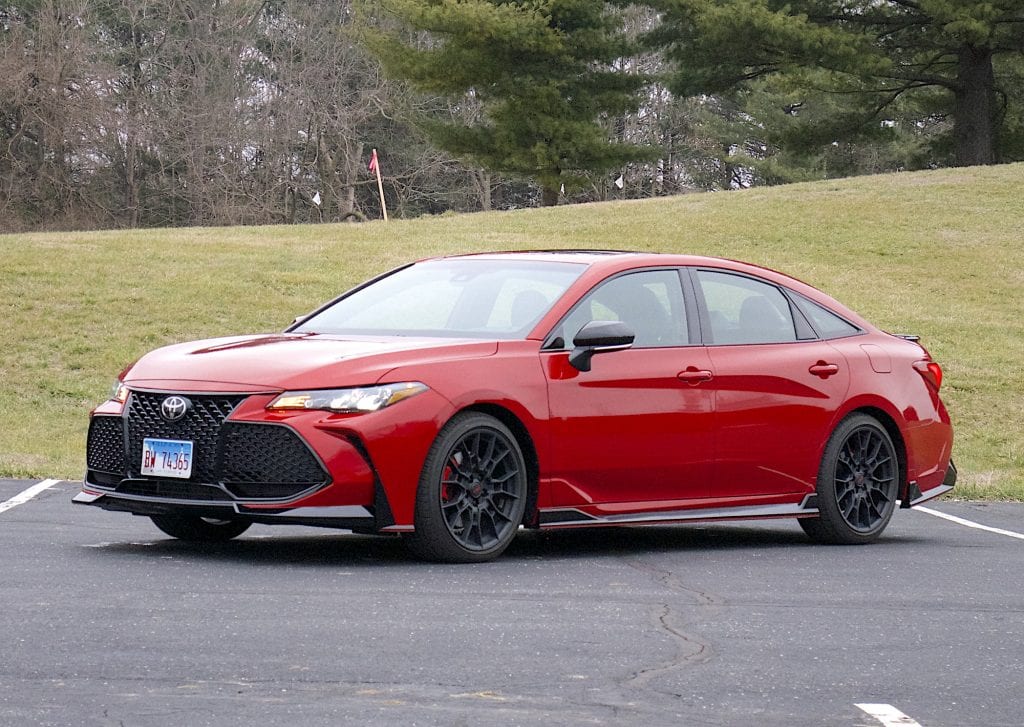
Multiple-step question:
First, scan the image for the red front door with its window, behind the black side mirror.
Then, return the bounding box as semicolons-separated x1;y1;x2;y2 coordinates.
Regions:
541;269;714;514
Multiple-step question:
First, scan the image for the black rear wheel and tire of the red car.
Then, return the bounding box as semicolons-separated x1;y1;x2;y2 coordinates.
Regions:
800;414;900;545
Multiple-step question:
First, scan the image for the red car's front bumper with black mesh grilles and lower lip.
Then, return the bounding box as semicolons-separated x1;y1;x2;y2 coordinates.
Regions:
80;390;393;529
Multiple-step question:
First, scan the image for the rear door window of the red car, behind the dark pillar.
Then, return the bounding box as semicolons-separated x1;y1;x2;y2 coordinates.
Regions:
697;270;797;345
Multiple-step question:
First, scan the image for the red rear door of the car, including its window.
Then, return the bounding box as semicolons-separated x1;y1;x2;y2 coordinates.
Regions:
692;268;850;499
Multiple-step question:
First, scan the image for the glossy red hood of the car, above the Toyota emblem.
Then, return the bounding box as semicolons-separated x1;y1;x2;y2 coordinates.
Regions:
125;333;498;393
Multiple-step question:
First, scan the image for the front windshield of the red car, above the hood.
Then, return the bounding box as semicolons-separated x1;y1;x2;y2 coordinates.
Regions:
293;258;586;339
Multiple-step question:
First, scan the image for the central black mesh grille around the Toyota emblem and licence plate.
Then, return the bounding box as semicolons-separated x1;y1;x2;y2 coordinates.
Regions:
128;391;245;482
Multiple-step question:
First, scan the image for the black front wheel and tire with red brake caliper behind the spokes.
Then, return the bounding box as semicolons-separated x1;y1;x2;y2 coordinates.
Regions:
406;412;528;563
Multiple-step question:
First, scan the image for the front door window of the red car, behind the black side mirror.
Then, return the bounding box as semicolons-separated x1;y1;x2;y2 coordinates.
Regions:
561;270;687;348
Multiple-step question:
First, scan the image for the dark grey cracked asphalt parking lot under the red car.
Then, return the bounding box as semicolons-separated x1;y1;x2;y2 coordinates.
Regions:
0;480;1024;727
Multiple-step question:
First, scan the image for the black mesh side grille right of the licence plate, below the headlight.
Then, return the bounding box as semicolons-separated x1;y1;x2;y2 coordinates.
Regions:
221;424;328;498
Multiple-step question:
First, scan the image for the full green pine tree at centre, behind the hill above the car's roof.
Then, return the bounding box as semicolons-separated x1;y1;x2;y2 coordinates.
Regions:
368;0;648;205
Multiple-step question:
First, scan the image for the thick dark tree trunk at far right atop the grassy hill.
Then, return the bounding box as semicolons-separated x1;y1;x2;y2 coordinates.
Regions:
953;45;996;167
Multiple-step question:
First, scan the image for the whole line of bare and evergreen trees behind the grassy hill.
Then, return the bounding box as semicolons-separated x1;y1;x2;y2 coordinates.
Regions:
0;0;1024;231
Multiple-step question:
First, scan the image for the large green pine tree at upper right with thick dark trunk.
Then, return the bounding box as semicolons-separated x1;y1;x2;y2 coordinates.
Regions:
649;0;1024;166
